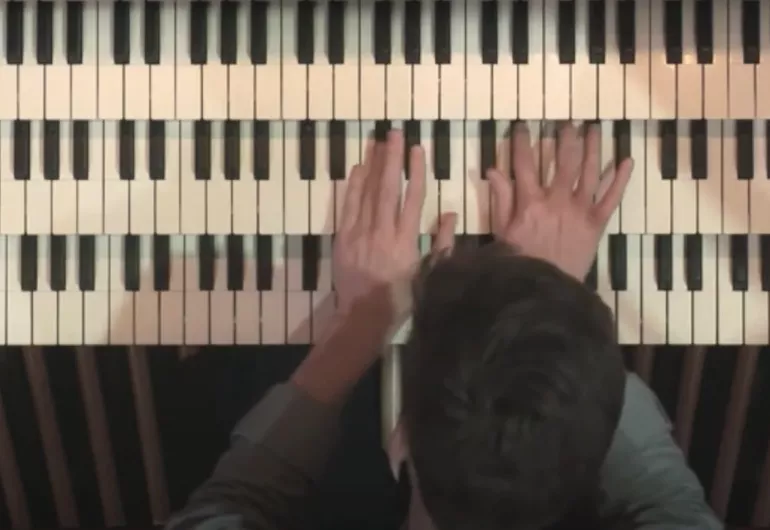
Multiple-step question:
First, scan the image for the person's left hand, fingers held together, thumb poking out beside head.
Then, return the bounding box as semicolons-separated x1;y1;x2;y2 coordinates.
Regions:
333;131;456;319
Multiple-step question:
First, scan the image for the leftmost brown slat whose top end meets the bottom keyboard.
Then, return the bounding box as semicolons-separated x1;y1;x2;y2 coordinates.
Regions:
22;347;78;528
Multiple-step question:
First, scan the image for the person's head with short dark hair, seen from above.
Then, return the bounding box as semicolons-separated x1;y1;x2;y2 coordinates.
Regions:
402;243;625;530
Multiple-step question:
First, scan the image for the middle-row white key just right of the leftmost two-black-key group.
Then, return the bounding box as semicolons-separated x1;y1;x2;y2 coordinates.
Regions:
155;121;181;234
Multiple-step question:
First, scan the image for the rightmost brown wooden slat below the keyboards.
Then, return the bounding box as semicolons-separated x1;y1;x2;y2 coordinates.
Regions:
711;347;759;520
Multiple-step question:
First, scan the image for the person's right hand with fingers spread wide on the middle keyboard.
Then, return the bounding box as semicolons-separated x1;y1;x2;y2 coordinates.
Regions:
488;124;632;281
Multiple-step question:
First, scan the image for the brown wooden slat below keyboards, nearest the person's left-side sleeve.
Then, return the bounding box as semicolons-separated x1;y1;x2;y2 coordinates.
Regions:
128;346;169;524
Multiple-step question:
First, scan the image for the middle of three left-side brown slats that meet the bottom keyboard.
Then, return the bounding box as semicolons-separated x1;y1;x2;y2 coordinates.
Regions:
77;347;126;527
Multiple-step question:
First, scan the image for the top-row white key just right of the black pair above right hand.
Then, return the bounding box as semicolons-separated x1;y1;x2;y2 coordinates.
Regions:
519;0;544;120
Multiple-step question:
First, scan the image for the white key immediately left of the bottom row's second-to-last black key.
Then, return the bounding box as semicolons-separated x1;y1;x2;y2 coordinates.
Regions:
717;235;743;344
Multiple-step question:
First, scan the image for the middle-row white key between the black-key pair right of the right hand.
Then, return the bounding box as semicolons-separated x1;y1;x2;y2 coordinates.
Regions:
671;120;698;234
